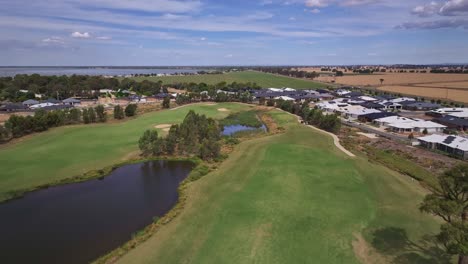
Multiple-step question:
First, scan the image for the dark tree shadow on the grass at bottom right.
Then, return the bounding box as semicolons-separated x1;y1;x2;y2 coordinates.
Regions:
372;227;451;264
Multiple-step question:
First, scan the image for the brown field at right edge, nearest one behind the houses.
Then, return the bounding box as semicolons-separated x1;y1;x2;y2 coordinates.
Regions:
377;85;468;103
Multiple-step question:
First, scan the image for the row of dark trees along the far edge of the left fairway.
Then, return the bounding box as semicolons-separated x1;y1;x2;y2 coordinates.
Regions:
0;104;137;143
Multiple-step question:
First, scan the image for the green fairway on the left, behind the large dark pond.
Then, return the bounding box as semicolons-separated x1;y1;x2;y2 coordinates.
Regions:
0;103;252;200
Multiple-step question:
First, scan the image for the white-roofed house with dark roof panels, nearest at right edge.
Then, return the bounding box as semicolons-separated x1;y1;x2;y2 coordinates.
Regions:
418;134;468;160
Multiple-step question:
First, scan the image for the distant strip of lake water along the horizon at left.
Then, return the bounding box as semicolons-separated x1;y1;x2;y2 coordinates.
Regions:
0;67;199;77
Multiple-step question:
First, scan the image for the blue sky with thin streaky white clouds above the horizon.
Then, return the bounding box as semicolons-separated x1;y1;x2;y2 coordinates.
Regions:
0;0;468;66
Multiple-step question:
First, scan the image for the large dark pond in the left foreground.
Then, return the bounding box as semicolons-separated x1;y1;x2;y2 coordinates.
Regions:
0;161;194;264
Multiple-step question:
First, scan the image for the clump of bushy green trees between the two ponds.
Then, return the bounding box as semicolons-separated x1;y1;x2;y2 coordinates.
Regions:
138;110;221;160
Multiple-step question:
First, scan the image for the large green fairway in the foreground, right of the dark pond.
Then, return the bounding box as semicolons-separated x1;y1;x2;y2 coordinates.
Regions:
120;112;437;263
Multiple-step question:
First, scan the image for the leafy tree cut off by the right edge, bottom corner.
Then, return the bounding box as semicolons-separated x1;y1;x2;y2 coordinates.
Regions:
420;164;468;264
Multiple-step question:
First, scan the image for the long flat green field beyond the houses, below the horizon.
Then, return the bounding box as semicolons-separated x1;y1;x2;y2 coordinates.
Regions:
126;71;327;89
